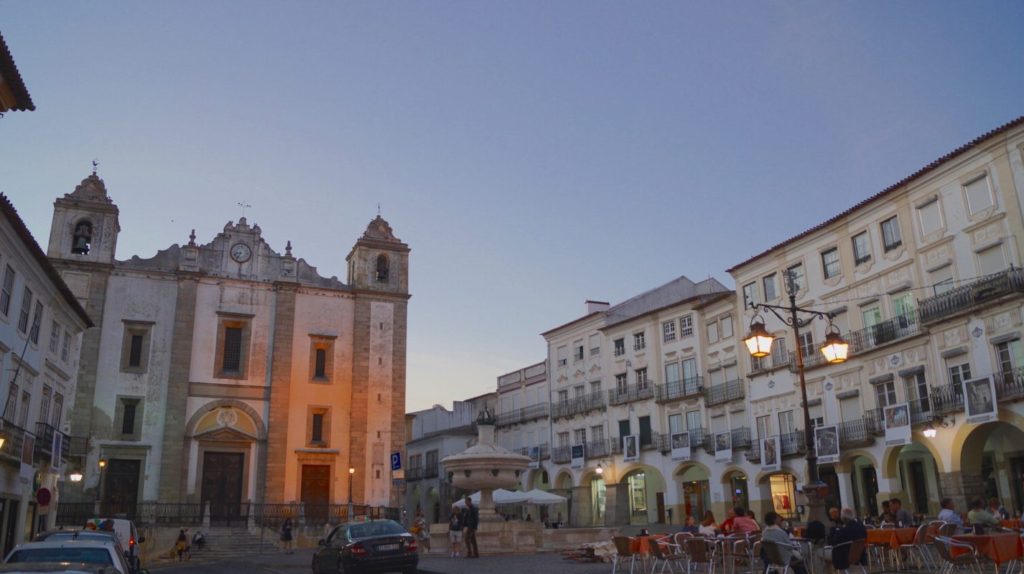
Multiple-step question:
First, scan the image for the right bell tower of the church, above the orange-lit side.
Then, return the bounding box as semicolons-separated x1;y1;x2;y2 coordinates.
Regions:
345;215;410;294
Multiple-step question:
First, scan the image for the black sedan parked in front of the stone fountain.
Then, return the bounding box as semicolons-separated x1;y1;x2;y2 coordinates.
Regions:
313;520;420;574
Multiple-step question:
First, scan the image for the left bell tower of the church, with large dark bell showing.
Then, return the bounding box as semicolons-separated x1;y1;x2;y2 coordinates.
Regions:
46;171;121;265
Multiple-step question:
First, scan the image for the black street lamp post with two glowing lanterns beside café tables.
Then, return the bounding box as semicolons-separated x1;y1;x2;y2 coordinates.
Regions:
743;270;849;522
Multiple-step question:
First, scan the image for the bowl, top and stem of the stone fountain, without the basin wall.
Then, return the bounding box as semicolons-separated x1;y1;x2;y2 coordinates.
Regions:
441;408;530;522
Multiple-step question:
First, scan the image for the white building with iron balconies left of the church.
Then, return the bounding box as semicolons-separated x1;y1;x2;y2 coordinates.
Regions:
0;194;92;555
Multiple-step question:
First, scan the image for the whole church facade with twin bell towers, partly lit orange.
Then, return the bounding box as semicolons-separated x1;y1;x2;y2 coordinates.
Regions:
47;173;410;515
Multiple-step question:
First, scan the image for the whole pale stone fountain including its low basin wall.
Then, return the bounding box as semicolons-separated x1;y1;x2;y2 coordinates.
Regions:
438;408;542;555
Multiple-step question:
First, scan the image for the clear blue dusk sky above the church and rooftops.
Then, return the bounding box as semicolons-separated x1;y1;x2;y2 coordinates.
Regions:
0;0;1024;411
